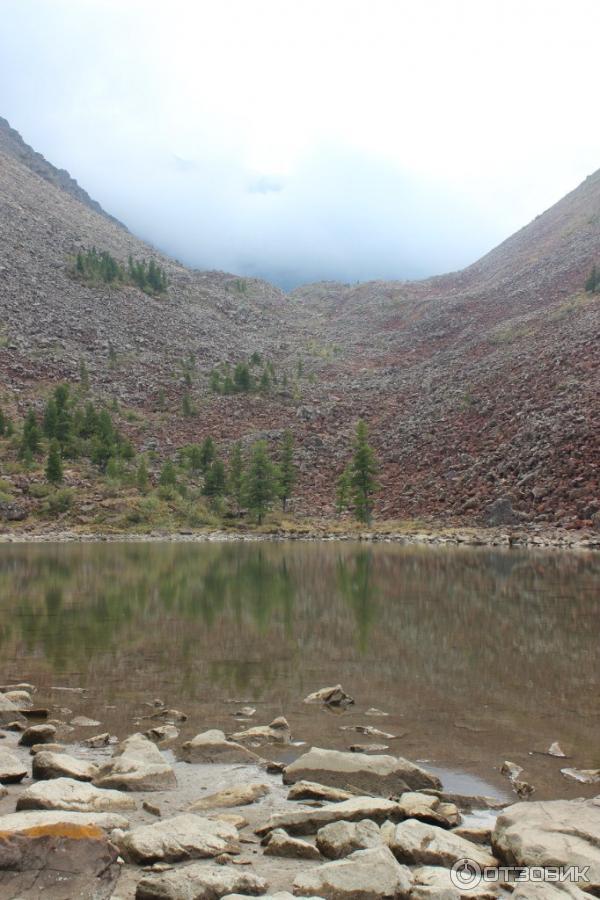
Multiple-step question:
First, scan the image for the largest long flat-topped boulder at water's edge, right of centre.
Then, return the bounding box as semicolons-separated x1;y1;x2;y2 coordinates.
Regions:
283;747;441;796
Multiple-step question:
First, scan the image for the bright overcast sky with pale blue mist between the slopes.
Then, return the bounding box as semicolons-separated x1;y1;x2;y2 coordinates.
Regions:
0;0;600;287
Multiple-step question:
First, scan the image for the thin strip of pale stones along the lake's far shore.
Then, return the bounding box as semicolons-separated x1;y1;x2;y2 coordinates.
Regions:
0;525;600;551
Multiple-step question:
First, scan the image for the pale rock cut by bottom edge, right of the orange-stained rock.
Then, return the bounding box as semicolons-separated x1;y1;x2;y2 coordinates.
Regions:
135;863;267;900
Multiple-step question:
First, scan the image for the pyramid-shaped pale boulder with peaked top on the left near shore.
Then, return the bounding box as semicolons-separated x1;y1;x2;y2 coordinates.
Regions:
94;734;177;791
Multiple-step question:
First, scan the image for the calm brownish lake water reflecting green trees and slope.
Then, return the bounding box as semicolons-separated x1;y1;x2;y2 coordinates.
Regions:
0;542;600;798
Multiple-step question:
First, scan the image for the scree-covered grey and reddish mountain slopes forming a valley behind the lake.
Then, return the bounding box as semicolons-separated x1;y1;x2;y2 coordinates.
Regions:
0;120;600;527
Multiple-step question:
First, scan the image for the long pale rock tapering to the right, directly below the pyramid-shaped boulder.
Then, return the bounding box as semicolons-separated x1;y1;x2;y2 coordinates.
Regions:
17;778;136;812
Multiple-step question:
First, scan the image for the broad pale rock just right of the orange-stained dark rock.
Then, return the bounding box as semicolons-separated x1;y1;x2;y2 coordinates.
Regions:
119;813;240;863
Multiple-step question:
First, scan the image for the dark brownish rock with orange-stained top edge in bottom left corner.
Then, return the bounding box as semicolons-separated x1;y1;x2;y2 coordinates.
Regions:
0;822;120;900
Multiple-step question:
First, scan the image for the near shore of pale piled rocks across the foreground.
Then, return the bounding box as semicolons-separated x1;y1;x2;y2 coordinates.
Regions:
0;684;600;900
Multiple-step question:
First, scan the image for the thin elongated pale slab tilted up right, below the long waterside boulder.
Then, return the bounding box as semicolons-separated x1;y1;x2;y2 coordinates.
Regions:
256;797;402;835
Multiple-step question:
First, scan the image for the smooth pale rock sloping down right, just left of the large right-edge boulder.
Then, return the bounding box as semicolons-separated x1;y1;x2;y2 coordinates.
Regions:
389;819;497;868
